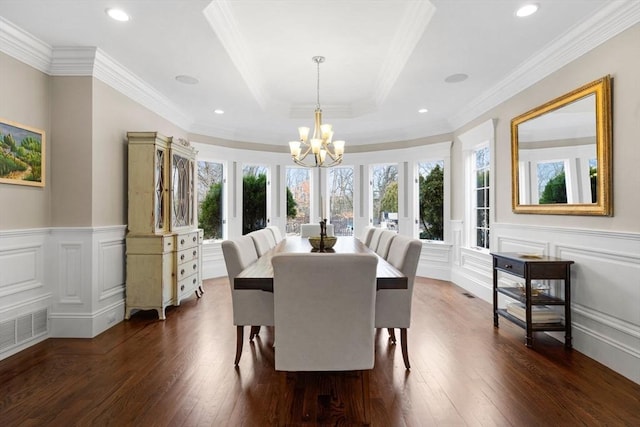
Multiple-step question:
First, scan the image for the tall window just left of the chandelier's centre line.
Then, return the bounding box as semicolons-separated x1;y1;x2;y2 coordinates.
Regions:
286;167;311;234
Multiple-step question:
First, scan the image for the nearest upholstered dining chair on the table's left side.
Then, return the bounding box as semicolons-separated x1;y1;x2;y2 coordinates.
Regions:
222;235;273;365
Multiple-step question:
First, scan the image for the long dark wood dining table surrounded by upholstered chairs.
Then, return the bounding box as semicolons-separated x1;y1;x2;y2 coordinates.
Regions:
233;236;408;292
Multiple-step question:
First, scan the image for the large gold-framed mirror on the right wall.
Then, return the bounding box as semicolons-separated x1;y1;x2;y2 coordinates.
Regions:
511;75;613;216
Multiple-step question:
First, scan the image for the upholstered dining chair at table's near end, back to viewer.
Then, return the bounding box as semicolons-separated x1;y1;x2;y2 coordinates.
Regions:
272;253;378;423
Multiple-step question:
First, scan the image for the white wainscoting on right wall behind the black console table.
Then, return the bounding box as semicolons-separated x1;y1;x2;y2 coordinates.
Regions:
487;223;640;383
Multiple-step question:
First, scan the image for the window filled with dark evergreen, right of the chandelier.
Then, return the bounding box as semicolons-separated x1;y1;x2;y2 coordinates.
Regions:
418;160;444;241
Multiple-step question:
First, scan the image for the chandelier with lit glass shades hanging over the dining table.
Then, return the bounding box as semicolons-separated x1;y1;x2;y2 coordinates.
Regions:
289;56;344;168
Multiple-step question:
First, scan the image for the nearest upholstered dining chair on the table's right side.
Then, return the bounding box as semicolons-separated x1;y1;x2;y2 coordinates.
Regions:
376;235;422;369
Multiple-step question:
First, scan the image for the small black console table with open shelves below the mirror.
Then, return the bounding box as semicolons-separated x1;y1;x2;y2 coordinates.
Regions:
491;252;573;348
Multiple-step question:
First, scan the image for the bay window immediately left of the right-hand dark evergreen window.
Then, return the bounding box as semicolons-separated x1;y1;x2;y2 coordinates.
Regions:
371;164;398;230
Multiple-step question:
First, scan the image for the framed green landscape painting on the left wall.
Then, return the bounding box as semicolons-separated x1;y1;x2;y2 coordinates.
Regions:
0;118;46;187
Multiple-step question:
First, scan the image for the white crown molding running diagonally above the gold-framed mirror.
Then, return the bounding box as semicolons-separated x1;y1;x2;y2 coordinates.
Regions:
449;0;640;129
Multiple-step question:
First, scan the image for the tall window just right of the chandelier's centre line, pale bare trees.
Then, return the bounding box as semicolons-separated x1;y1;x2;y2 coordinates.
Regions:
329;167;353;236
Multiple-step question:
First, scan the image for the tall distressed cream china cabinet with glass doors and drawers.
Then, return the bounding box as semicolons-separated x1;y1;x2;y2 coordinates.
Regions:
125;132;203;320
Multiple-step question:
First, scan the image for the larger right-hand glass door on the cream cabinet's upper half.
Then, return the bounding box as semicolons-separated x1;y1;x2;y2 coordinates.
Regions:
171;154;194;227
